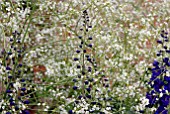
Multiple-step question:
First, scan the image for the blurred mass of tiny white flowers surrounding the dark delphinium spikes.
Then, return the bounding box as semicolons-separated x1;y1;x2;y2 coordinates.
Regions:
0;0;170;113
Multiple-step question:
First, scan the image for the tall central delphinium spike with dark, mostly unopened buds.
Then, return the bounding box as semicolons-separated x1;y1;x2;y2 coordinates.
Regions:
68;10;112;114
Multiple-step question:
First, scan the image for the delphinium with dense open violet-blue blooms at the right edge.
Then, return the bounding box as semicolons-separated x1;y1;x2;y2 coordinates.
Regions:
141;30;170;114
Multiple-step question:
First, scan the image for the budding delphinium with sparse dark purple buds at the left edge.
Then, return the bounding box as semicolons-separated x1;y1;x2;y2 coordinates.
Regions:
0;31;32;114
